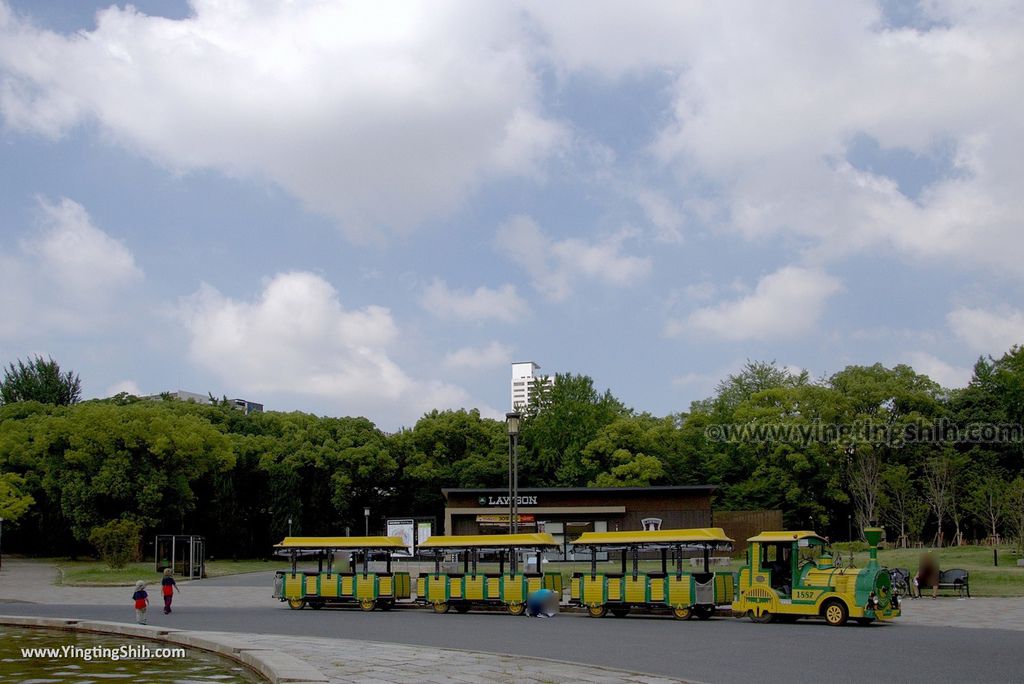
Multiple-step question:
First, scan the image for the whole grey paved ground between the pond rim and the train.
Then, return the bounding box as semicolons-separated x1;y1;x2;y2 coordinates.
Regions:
0;561;1024;684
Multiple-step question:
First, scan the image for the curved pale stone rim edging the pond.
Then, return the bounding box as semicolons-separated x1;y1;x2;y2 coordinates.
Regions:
0;615;330;684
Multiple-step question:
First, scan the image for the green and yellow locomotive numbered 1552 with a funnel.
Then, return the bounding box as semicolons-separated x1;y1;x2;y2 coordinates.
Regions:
732;527;900;626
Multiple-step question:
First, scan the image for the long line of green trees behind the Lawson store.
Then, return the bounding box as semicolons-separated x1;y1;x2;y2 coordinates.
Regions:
0;347;1024;557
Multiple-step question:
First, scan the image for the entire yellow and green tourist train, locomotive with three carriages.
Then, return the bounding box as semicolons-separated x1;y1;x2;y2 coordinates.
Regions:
273;527;900;626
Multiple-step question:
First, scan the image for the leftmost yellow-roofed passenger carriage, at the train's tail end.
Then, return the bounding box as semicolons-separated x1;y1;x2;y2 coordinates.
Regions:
273;537;412;610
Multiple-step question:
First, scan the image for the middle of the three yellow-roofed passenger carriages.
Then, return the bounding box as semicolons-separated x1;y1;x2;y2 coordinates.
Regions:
417;532;562;615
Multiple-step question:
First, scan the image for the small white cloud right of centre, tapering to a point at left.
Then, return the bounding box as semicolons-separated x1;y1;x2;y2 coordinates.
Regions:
666;266;841;341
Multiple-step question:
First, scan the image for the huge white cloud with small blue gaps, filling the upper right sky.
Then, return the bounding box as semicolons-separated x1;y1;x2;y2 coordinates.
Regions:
530;0;1024;279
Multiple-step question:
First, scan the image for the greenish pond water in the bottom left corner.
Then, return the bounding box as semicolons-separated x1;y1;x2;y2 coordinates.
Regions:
0;626;263;684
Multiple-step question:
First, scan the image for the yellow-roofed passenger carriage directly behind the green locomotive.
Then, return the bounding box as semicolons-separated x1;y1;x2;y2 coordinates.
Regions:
569;527;733;619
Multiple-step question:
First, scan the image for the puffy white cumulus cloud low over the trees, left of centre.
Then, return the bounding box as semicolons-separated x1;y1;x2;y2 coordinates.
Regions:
180;272;469;420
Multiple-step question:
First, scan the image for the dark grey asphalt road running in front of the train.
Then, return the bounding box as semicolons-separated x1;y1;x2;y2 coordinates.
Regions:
0;573;1024;684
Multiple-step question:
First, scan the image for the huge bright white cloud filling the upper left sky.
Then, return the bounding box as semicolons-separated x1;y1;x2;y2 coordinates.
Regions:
0;0;566;238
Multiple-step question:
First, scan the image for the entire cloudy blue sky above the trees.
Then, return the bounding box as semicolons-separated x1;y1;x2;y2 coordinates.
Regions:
0;0;1024;430
